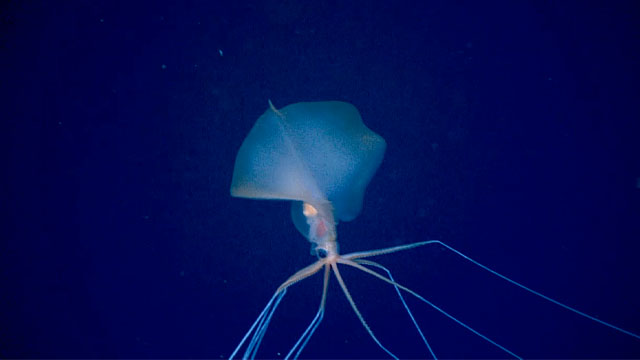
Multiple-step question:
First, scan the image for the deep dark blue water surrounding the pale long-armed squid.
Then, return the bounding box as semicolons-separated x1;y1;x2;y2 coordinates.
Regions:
0;0;640;359
